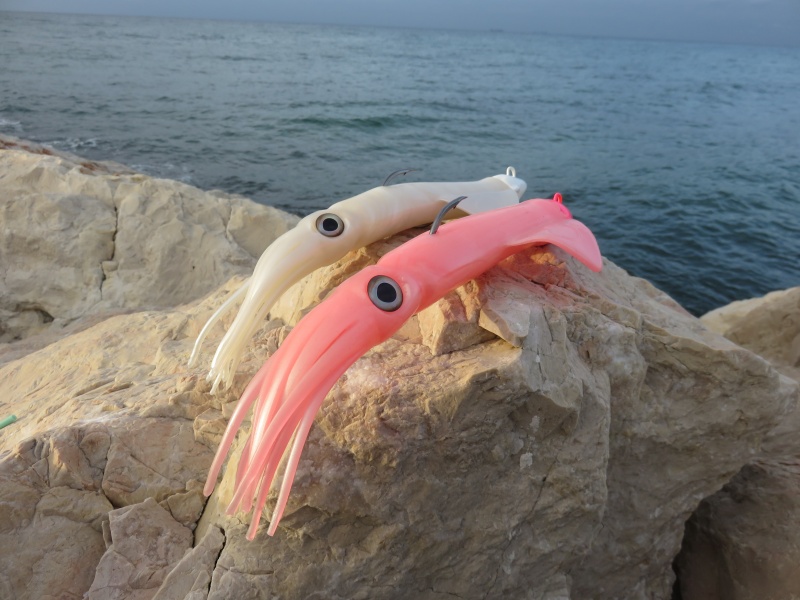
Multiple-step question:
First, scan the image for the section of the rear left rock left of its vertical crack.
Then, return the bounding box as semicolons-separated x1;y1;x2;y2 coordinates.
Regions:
0;176;116;341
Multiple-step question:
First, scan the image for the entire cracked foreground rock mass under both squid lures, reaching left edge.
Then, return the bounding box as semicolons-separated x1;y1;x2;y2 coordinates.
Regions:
0;138;797;600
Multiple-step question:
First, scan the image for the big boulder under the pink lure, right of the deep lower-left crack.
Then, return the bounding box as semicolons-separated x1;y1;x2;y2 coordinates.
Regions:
200;235;796;598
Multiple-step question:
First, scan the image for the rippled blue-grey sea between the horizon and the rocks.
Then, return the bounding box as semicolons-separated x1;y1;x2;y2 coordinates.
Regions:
0;12;800;314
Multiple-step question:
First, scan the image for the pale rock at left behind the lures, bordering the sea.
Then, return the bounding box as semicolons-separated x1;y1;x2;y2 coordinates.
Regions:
0;137;297;342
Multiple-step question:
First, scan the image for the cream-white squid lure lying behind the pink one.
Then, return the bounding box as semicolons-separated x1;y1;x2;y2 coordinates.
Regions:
189;167;526;392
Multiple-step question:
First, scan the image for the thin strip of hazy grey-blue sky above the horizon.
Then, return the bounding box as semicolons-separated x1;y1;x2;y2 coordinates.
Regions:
0;0;800;46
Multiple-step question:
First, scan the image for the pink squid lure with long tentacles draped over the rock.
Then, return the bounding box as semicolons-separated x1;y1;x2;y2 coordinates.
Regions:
204;195;602;539
